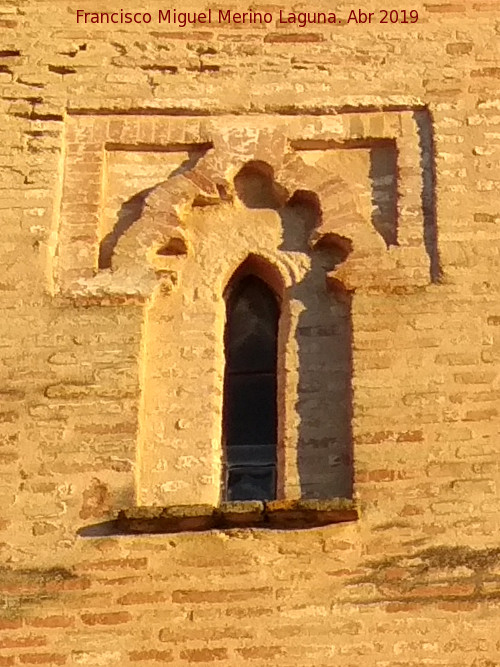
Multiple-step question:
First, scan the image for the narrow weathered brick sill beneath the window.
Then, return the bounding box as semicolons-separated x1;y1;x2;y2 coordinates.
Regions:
79;498;358;537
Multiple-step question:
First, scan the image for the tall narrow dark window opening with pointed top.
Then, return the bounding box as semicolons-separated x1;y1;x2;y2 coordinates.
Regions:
223;275;280;501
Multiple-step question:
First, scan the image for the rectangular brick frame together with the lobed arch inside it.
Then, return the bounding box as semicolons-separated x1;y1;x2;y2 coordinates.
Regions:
50;109;437;305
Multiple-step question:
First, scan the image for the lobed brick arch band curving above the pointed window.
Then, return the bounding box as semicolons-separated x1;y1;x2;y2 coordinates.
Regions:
113;129;378;289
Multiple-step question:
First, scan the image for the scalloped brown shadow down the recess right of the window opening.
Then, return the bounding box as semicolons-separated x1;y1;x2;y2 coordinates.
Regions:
235;163;353;499
